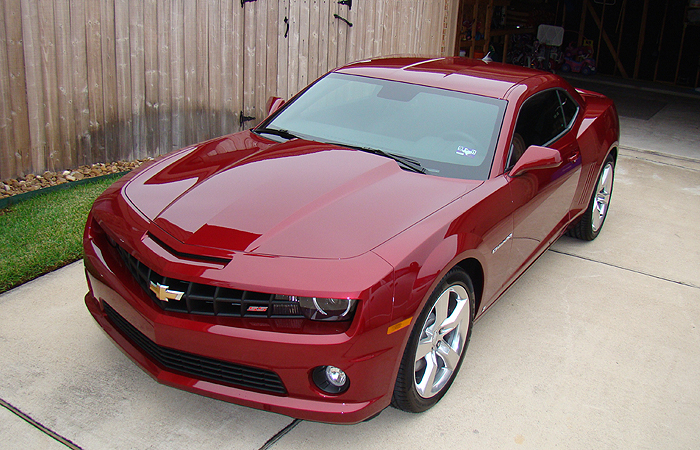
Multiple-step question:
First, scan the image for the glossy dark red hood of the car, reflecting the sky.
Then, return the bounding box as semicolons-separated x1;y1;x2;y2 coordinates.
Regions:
123;132;481;258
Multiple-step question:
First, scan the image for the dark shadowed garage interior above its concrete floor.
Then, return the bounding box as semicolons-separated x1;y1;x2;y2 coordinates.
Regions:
455;0;700;89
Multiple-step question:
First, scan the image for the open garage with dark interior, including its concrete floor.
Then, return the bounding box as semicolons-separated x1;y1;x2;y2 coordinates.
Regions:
454;0;700;160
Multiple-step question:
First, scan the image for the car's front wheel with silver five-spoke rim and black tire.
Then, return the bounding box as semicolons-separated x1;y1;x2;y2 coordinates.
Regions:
391;267;476;413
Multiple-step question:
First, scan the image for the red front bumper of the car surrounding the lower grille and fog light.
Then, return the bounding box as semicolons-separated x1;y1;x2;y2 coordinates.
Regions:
84;213;405;423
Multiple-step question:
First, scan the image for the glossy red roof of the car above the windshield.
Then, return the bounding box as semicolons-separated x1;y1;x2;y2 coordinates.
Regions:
334;57;561;98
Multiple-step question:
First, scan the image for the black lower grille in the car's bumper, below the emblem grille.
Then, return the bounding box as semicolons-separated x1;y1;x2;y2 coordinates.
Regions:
103;303;287;395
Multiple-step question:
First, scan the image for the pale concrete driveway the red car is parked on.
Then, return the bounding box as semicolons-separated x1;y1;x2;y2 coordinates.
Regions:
0;150;700;450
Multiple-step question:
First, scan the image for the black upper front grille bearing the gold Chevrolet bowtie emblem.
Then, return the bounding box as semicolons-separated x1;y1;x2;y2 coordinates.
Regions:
117;247;304;319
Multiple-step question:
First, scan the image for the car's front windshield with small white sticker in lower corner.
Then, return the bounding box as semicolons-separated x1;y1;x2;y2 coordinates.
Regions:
261;73;506;180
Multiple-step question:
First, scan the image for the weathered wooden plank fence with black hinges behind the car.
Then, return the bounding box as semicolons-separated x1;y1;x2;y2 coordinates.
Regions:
0;0;457;179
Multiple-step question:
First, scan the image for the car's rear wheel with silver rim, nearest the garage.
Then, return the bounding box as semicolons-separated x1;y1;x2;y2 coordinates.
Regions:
566;155;615;241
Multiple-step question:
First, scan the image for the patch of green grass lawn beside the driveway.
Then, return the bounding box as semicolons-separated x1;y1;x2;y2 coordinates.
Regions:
0;177;117;292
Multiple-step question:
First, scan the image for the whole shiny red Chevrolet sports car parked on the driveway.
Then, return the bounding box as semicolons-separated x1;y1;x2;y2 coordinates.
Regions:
84;58;619;423
